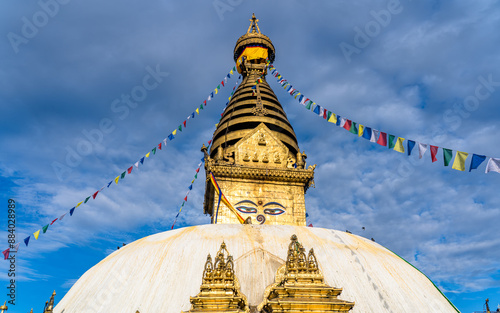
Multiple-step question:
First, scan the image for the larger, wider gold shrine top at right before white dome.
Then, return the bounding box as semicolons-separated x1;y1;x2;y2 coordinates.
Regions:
257;235;354;313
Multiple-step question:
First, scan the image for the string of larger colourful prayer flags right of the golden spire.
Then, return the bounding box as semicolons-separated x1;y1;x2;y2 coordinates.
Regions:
268;60;500;173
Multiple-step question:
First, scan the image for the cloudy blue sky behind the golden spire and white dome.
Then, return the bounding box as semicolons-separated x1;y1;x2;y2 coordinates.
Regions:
0;0;500;312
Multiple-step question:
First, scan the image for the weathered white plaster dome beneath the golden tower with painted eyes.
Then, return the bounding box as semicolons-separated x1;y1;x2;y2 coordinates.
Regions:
54;224;456;313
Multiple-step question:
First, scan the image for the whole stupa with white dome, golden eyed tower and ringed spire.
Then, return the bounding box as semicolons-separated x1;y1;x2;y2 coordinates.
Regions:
53;16;458;313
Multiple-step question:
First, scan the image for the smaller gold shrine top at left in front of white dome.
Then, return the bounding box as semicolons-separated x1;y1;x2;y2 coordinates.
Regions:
184;242;250;313
